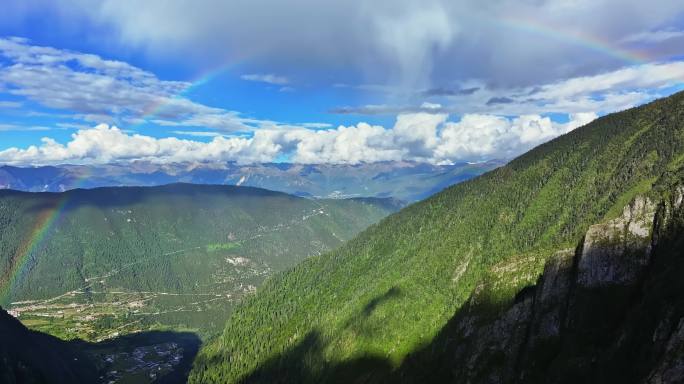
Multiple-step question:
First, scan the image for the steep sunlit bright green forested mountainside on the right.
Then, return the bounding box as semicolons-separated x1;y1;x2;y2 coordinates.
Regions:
190;93;684;383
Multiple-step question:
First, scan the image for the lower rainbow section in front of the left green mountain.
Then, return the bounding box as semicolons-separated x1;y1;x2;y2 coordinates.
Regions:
0;168;92;302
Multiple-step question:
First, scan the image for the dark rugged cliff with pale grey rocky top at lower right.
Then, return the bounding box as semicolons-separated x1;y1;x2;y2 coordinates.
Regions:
393;187;684;384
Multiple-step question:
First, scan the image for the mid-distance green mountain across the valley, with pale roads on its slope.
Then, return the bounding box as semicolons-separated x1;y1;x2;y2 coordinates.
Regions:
0;184;399;341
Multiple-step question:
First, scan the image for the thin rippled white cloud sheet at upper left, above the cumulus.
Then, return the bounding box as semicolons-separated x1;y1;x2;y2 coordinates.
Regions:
0;38;312;131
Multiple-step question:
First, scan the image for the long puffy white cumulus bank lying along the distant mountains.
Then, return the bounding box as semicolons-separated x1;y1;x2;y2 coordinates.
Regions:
0;113;596;165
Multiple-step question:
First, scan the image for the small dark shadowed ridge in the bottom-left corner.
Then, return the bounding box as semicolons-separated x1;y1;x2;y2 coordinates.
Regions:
0;308;97;384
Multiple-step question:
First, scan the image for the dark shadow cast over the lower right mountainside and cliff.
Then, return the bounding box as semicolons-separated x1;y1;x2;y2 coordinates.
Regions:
231;195;684;384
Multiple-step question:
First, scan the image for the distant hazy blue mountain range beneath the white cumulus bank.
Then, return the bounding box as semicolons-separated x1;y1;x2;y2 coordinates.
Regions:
0;161;504;201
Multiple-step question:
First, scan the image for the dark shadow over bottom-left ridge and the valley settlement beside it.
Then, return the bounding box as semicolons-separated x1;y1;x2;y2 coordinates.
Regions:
0;310;201;384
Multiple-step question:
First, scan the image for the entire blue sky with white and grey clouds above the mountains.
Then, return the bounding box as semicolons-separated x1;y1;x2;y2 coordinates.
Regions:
0;0;684;165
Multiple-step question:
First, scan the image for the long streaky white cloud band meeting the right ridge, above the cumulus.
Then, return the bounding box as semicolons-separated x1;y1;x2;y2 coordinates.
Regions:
331;61;684;116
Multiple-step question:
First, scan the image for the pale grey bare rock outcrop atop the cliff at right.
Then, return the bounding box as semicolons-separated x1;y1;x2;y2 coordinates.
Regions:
578;197;656;288
